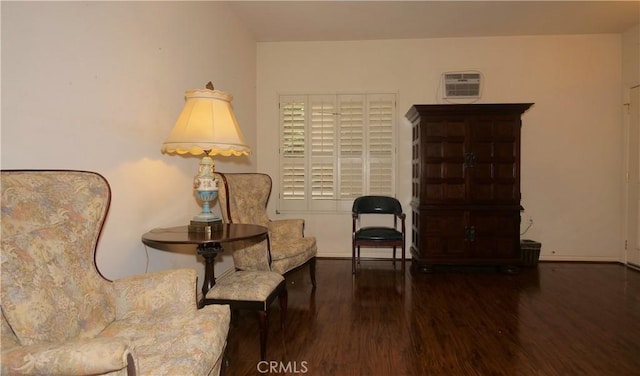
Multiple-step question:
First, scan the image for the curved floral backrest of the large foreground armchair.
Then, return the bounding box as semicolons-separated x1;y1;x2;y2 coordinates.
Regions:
1;170;115;345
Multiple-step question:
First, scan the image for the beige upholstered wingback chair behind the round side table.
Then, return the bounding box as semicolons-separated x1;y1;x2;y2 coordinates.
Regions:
216;173;317;288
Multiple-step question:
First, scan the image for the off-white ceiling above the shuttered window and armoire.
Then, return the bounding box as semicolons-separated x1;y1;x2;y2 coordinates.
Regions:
228;0;640;42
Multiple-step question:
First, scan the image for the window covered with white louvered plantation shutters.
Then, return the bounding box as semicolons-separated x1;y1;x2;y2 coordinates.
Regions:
279;94;396;211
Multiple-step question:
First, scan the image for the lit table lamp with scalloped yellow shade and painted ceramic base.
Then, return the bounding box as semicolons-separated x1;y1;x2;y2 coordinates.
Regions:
162;82;251;232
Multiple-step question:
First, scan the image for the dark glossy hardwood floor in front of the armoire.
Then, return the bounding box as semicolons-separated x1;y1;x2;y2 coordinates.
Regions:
226;259;640;376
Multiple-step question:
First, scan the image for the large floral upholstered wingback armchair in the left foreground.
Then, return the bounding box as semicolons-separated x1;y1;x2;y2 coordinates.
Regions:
0;171;230;376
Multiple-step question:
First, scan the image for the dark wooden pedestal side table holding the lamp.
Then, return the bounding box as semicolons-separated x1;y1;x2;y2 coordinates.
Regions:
142;224;268;306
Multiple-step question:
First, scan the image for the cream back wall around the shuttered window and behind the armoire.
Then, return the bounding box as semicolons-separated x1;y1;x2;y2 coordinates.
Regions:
257;34;622;261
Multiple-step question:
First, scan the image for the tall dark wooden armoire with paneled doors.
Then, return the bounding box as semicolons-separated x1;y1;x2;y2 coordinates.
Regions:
406;103;532;272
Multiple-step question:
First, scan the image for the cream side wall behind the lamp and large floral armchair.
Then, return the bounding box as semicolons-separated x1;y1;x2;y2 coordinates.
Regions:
1;2;257;280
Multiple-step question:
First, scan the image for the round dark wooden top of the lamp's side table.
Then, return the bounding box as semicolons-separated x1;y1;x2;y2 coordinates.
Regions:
142;224;268;246
